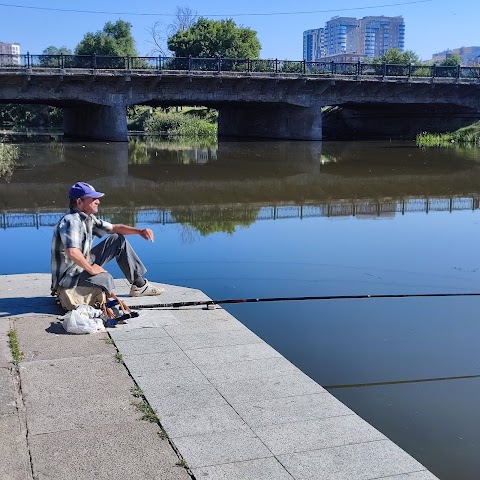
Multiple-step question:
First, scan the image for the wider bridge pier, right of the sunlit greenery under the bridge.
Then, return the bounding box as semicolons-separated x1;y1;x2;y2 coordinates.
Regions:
218;103;322;140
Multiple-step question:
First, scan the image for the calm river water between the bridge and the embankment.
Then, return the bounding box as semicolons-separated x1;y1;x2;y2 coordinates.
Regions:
0;137;480;480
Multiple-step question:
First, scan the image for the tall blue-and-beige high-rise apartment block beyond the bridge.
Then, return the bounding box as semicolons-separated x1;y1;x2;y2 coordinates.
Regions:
303;16;405;61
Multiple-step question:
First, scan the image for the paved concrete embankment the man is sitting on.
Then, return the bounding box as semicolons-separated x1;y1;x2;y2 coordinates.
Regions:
0;274;436;480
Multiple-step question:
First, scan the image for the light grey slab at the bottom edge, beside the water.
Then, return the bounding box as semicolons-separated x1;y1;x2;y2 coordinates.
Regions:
277;439;435;480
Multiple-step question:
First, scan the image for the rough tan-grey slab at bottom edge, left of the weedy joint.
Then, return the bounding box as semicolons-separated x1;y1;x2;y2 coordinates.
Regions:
30;421;190;480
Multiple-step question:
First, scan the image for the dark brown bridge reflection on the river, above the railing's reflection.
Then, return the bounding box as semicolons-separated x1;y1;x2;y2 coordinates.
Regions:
0;139;480;210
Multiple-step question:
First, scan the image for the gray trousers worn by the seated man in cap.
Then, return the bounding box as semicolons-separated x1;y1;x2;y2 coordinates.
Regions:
77;233;147;293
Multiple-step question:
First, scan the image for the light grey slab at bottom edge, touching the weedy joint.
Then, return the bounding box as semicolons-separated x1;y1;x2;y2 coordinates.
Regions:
193;458;294;480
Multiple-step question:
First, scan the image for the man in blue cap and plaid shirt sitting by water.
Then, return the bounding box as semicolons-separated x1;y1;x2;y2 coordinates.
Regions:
51;182;165;304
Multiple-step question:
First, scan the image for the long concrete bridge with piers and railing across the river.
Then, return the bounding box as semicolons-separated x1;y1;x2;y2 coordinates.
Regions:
0;56;480;141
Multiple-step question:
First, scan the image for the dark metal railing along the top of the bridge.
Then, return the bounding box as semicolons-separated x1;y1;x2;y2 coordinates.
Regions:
0;53;480;80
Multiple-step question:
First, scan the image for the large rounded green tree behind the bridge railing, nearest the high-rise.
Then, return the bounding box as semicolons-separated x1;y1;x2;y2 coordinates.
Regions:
167;17;261;58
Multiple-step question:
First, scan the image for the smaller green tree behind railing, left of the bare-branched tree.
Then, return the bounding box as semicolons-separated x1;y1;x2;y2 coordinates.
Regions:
75;20;138;57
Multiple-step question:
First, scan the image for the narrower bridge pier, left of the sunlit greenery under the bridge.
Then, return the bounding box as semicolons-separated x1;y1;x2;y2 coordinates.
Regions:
63;104;128;142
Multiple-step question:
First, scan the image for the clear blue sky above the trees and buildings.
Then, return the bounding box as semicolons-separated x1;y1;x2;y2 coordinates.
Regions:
0;0;480;60
